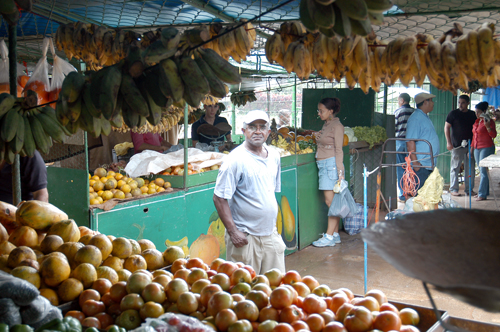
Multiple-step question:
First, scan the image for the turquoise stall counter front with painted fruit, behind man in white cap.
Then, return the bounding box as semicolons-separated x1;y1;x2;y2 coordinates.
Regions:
91;155;300;261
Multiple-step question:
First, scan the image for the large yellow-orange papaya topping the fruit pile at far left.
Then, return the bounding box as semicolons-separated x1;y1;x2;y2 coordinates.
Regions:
16;200;68;231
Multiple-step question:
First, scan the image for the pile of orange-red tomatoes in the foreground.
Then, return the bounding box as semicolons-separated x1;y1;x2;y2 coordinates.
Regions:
64;258;419;332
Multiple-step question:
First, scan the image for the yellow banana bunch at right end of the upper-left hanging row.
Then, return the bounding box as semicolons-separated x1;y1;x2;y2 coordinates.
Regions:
203;20;257;63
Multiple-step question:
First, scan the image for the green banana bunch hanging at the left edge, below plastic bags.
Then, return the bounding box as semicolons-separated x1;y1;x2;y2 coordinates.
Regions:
0;91;69;164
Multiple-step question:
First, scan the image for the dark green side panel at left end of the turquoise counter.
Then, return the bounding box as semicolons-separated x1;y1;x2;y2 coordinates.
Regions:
47;167;89;227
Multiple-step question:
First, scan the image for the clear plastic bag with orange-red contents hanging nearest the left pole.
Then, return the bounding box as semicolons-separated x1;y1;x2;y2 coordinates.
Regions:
24;37;50;105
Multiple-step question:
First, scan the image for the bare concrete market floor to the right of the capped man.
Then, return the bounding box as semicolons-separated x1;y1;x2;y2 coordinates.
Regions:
286;169;500;325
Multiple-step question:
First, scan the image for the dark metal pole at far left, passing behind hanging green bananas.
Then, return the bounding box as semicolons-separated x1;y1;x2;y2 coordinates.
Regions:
9;25;21;206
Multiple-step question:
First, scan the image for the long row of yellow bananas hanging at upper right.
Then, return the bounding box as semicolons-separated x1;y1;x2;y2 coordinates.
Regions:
266;23;500;94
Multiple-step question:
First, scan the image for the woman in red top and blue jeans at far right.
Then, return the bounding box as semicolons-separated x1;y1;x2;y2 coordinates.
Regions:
472;101;497;201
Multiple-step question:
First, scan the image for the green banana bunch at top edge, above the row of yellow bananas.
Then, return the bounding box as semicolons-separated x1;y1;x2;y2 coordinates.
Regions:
299;0;393;37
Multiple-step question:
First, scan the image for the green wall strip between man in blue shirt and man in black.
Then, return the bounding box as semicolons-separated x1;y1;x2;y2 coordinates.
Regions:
429;86;457;183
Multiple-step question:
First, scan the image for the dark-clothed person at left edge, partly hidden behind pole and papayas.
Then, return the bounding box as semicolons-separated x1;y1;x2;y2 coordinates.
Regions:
0;150;49;204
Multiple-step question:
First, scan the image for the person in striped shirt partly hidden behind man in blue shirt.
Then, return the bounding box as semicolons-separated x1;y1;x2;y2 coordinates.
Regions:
394;93;415;202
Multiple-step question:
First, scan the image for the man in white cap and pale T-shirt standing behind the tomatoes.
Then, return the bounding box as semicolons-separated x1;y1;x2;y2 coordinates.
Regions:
213;111;286;274
